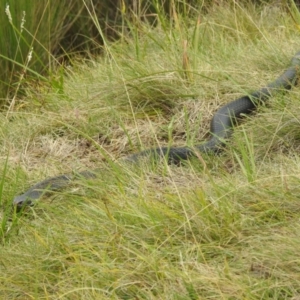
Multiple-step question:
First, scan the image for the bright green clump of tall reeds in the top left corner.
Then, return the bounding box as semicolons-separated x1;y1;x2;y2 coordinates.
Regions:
0;0;83;105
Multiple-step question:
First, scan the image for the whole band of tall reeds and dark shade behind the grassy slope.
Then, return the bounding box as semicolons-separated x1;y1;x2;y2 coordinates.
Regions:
0;0;278;108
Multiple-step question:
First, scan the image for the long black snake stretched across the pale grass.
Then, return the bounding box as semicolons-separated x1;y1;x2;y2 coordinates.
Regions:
13;51;300;210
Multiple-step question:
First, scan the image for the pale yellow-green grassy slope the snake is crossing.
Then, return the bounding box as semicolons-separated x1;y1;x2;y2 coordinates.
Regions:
0;2;300;299
